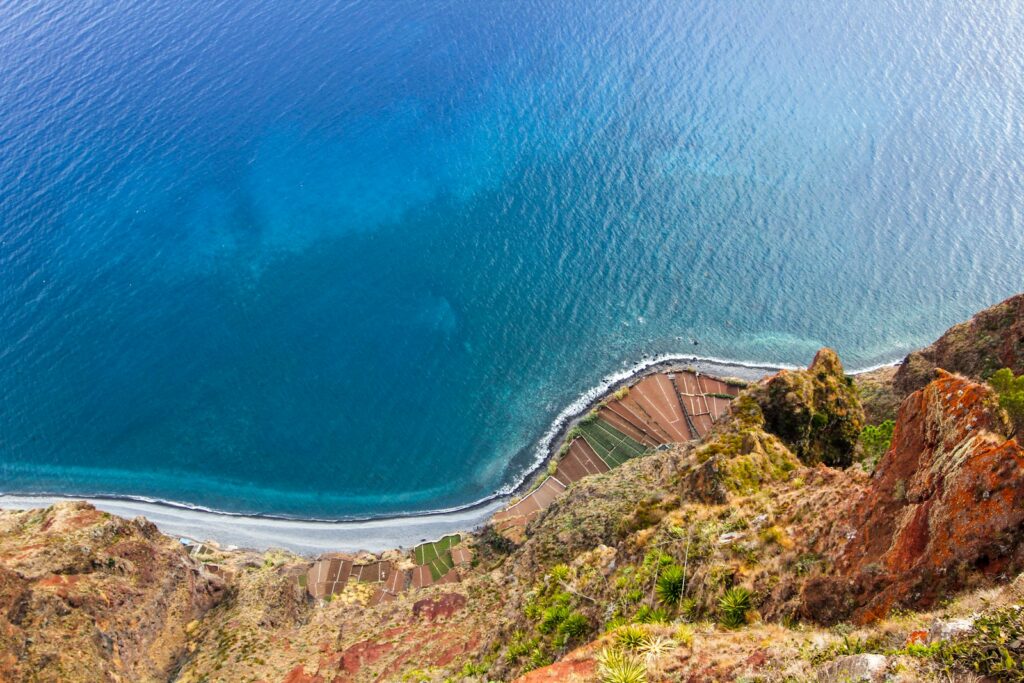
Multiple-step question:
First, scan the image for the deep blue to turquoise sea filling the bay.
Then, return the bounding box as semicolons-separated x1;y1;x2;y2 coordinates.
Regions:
0;0;1024;517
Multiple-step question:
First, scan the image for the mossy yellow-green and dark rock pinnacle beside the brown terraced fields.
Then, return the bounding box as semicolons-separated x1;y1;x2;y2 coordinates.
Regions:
753;348;864;467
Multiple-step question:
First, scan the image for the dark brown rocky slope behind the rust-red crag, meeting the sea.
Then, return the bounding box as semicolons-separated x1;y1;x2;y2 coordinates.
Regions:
894;294;1024;396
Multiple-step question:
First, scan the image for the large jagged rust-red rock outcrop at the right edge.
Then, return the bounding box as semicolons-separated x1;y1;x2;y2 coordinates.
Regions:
805;371;1024;623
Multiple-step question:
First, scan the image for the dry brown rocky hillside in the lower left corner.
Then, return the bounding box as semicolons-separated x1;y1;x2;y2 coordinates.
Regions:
0;503;223;682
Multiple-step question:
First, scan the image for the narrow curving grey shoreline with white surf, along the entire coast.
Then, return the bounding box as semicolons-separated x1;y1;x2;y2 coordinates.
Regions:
0;353;899;555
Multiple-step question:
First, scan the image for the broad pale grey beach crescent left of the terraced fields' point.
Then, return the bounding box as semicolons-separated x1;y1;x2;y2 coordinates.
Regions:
0;496;504;555
